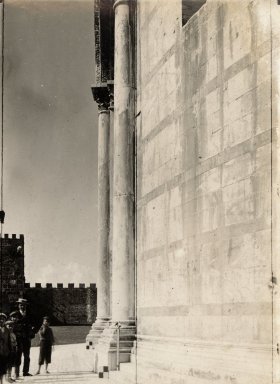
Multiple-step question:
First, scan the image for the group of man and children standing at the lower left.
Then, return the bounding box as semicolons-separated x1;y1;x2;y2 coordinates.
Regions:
0;298;54;384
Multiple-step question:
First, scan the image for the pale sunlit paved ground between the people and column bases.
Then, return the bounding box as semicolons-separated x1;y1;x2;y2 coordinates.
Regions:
8;343;108;384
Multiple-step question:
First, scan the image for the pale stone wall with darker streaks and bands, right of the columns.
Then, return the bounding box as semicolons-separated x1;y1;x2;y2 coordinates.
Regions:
135;0;280;384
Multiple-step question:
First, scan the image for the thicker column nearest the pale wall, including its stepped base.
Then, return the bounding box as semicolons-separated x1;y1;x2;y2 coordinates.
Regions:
96;0;136;370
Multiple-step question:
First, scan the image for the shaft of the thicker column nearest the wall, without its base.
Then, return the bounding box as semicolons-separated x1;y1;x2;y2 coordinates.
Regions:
112;1;134;321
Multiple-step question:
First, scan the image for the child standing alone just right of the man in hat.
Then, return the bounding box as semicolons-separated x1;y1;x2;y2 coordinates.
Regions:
36;316;54;375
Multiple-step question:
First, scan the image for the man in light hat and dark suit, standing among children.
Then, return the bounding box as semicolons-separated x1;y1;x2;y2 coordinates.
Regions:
10;298;35;378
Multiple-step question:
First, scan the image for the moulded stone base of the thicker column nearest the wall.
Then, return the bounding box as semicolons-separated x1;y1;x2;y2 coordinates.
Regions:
95;321;136;371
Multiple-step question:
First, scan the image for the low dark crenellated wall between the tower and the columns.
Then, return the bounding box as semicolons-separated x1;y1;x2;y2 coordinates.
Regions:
24;283;97;325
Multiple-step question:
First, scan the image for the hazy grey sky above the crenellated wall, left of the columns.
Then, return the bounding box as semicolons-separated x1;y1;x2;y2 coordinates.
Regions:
3;0;97;285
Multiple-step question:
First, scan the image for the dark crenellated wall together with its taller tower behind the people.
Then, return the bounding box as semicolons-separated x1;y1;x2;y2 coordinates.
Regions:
0;234;97;326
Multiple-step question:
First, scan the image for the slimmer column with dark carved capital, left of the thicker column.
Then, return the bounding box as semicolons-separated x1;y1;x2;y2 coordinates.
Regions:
86;84;111;348
